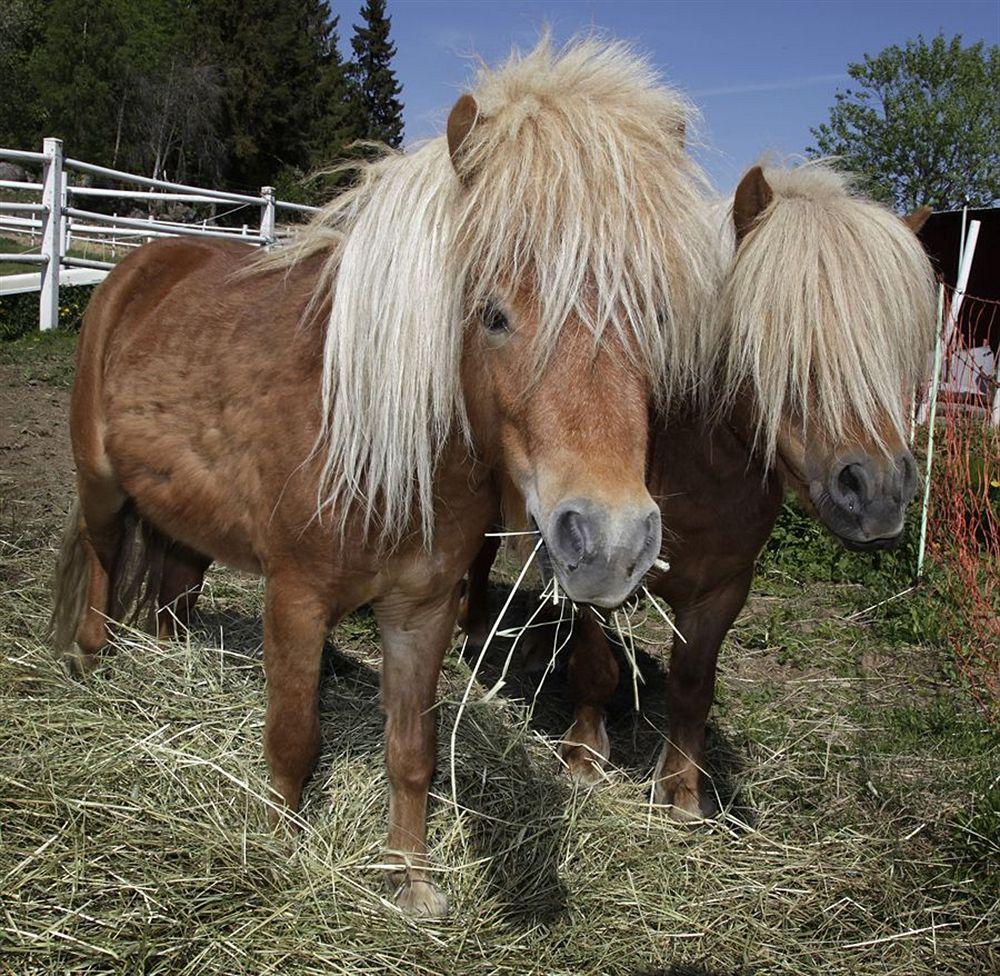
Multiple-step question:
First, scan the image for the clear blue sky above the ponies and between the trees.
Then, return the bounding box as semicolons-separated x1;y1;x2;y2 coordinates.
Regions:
338;0;1000;189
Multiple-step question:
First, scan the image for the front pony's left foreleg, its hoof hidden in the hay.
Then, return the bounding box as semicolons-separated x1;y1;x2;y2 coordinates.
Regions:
264;576;330;826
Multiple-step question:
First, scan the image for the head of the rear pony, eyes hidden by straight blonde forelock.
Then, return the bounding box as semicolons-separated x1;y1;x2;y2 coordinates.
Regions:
718;163;935;549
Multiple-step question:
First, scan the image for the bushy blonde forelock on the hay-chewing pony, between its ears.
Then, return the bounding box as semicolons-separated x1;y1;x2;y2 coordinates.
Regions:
460;40;719;399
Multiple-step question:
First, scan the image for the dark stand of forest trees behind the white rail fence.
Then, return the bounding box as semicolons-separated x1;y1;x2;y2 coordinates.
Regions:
0;0;386;196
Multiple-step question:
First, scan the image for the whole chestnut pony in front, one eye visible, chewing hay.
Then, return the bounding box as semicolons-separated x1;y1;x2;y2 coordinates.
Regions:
52;39;717;915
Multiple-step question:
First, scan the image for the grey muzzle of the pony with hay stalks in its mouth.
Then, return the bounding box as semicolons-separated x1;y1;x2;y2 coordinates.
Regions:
536;498;661;607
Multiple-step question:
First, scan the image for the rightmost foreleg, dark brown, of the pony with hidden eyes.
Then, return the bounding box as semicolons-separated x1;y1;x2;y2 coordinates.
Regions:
653;570;753;820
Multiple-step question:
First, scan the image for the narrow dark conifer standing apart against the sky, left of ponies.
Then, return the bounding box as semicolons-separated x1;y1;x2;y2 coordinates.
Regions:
351;0;403;147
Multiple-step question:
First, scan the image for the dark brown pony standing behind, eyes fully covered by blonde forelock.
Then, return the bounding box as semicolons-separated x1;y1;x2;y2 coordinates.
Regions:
467;164;934;819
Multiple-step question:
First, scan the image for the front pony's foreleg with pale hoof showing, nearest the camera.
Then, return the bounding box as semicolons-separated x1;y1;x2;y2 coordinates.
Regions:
375;587;458;916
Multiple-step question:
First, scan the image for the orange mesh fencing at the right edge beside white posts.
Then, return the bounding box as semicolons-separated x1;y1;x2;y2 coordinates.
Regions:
927;288;1000;720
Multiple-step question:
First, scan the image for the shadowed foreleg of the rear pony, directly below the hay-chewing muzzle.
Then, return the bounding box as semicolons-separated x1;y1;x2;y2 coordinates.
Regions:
559;610;618;786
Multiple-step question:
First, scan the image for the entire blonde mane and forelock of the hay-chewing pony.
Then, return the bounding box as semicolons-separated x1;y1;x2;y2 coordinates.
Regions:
276;38;718;540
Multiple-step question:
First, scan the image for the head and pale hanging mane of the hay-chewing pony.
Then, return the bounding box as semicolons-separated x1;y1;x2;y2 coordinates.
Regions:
286;39;718;606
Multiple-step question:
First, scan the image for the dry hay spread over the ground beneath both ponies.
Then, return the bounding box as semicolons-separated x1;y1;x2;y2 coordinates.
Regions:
0;508;1000;976
